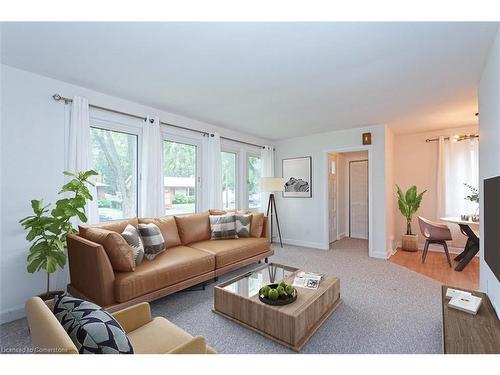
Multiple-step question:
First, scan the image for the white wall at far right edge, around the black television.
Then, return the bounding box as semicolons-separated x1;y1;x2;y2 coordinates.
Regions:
479;29;500;315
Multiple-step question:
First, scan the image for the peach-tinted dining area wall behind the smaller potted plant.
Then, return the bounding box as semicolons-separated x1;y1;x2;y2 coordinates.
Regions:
392;126;478;251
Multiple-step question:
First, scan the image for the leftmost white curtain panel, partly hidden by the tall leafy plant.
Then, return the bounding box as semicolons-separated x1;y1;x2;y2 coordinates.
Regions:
67;96;99;225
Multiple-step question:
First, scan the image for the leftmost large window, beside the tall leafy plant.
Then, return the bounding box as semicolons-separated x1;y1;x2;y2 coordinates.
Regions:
91;128;138;222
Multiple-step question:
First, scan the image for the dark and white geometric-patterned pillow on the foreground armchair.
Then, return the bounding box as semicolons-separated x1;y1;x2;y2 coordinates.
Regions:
54;295;134;354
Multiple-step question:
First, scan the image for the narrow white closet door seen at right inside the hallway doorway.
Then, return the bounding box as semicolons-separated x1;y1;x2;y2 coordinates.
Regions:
349;160;368;239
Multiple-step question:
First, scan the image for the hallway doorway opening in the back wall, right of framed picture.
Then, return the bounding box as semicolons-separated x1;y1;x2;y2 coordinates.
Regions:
327;151;370;248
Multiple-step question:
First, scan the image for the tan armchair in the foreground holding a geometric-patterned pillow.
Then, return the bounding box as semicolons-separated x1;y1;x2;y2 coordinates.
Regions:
26;297;215;354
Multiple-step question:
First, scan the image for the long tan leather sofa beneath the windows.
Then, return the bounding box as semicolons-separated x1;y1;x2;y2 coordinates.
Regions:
67;212;274;311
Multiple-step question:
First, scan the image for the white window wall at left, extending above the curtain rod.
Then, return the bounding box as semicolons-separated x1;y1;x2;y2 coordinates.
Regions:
0;65;269;322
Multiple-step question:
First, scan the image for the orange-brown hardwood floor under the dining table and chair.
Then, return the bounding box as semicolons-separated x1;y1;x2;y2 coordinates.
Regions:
389;249;479;290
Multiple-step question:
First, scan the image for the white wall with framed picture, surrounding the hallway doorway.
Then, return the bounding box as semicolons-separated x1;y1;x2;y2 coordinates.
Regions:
275;125;387;258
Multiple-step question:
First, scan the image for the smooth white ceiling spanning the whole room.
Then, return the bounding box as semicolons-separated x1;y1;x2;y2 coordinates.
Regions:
2;22;499;139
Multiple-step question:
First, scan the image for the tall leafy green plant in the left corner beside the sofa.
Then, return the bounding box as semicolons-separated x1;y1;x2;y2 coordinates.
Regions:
19;170;97;301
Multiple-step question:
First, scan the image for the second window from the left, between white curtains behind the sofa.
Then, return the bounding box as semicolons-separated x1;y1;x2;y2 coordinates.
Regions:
163;141;197;215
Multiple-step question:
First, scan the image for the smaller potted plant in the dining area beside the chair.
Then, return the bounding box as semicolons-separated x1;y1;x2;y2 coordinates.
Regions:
396;185;427;251
